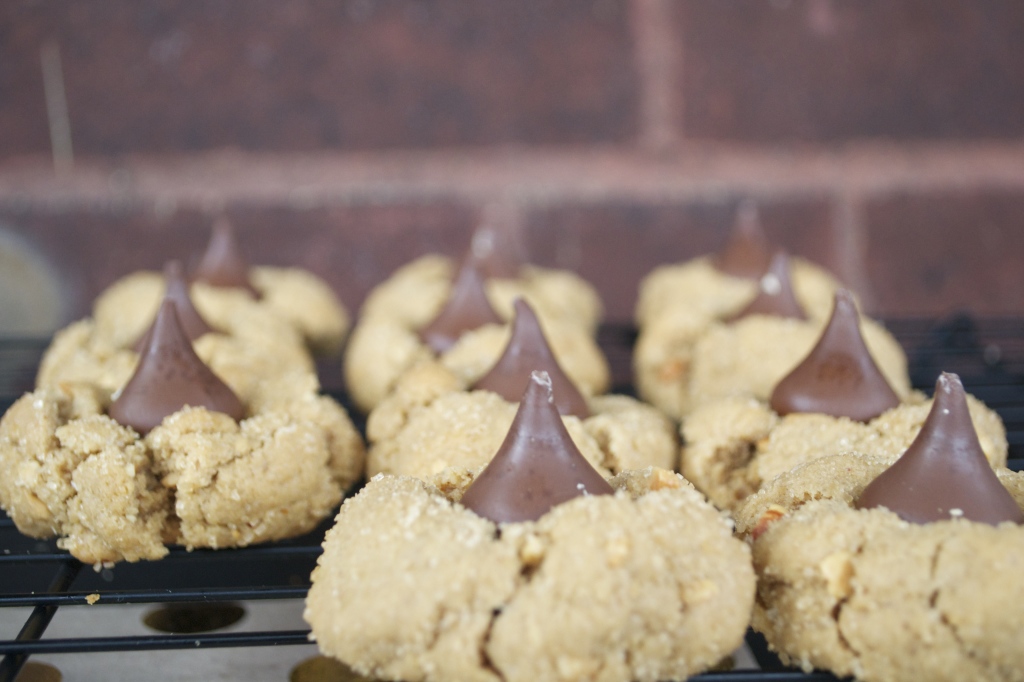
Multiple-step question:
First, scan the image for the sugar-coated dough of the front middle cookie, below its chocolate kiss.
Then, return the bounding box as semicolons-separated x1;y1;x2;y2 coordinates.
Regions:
304;469;754;681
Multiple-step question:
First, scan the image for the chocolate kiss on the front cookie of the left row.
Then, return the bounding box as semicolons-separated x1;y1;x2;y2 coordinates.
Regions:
108;299;245;434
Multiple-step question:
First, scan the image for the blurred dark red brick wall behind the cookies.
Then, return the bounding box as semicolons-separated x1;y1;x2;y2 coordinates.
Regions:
0;0;1024;331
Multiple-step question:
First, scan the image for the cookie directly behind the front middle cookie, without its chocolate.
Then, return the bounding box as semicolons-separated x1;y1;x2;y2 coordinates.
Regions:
367;360;678;480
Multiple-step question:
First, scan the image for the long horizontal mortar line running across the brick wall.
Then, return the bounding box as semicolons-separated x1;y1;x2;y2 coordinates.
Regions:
0;142;1024;213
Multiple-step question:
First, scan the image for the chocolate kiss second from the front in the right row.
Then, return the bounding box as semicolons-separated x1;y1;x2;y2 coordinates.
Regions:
770;289;900;422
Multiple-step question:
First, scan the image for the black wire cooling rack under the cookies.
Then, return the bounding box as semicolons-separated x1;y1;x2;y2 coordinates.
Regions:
0;315;1024;682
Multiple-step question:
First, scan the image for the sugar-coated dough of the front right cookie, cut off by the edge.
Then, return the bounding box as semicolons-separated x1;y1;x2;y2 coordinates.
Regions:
735;455;1024;681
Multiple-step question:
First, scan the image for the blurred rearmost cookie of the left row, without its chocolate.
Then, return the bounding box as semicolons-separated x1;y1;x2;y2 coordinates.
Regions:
93;265;349;353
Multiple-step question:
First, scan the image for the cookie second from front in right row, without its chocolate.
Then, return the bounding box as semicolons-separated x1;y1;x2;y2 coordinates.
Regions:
680;393;1009;509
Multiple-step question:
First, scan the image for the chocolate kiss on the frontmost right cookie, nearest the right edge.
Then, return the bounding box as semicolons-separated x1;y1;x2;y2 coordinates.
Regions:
856;373;1024;525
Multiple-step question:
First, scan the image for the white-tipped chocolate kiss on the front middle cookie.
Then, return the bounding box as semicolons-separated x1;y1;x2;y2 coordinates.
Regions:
462;372;612;523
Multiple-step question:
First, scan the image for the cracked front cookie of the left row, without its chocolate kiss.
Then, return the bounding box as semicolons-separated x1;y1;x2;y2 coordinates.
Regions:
0;371;364;564
